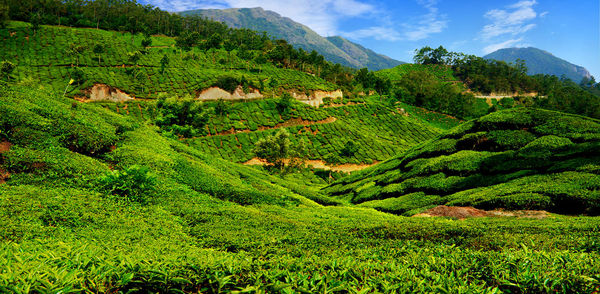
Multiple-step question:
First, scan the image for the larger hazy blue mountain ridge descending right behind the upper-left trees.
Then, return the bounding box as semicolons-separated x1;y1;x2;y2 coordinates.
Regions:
180;7;403;70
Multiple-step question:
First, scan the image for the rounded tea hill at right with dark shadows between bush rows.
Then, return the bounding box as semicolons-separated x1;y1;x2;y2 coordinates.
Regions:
325;108;600;215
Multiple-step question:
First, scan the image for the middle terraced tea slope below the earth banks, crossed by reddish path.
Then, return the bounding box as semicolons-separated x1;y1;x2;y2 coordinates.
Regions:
100;98;440;165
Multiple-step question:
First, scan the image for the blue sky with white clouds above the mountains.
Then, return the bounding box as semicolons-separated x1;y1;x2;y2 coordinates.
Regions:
141;0;600;79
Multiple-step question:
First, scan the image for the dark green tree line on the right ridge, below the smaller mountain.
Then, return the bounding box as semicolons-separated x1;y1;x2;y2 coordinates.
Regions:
410;46;600;118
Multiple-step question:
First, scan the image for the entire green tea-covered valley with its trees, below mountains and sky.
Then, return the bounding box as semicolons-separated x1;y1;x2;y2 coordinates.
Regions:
0;0;600;293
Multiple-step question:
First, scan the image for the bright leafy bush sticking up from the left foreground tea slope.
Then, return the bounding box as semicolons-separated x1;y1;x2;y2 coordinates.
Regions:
98;165;156;204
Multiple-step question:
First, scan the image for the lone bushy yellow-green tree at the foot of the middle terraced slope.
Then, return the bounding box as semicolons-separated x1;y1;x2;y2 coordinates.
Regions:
253;129;290;170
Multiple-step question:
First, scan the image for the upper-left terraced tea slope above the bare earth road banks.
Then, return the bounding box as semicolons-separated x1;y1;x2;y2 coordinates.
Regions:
0;22;335;98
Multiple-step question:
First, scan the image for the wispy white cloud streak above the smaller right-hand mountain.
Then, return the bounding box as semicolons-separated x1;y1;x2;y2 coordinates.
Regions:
480;0;547;54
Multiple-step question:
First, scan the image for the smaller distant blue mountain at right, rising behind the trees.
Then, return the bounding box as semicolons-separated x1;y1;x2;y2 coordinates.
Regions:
484;47;591;83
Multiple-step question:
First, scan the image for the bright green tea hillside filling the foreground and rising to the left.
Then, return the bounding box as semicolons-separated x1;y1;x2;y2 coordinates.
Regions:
0;85;600;293
